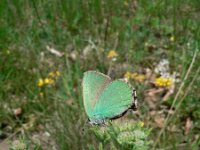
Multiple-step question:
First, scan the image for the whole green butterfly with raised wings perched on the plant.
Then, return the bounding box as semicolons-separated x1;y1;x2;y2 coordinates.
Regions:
82;71;137;124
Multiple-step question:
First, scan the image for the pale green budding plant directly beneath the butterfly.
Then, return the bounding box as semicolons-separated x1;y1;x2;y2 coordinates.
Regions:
90;121;151;150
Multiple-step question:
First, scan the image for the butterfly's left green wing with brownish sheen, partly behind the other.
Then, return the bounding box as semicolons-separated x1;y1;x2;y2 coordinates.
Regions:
82;71;111;117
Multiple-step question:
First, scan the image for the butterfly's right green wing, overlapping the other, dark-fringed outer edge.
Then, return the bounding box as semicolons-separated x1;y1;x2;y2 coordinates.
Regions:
92;80;133;120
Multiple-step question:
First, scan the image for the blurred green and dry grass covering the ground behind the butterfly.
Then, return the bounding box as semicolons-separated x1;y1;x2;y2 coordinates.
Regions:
0;0;200;149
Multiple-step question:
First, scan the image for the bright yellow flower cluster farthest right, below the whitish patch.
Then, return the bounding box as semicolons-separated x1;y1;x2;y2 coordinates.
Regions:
155;77;173;87
